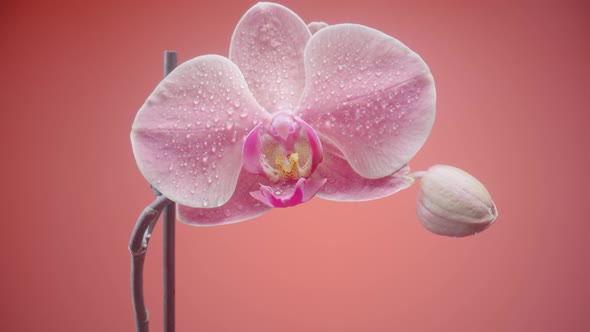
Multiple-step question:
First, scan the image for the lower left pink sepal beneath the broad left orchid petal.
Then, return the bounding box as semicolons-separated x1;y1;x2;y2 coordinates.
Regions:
176;170;270;226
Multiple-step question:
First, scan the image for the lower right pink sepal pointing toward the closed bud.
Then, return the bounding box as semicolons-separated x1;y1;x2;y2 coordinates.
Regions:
317;143;414;201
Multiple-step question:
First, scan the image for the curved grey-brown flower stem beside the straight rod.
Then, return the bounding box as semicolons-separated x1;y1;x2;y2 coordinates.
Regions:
129;196;173;332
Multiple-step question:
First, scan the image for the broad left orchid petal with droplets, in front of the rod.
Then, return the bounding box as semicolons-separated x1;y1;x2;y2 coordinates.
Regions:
131;55;269;207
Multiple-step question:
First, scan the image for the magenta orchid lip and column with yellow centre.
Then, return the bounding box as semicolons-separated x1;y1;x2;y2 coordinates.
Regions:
243;113;325;207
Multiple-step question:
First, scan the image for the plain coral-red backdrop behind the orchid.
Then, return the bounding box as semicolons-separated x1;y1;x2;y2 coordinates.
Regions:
0;0;590;332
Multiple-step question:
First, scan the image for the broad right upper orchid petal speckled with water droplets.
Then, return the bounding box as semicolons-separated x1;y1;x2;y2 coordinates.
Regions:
298;24;436;179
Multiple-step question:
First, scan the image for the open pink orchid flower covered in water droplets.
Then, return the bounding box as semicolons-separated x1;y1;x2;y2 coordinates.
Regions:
131;3;436;225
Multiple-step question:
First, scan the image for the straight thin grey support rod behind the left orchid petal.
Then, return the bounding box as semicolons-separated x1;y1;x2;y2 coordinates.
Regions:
163;51;178;332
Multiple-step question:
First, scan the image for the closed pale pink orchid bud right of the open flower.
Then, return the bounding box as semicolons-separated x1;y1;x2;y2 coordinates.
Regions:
416;165;498;237
